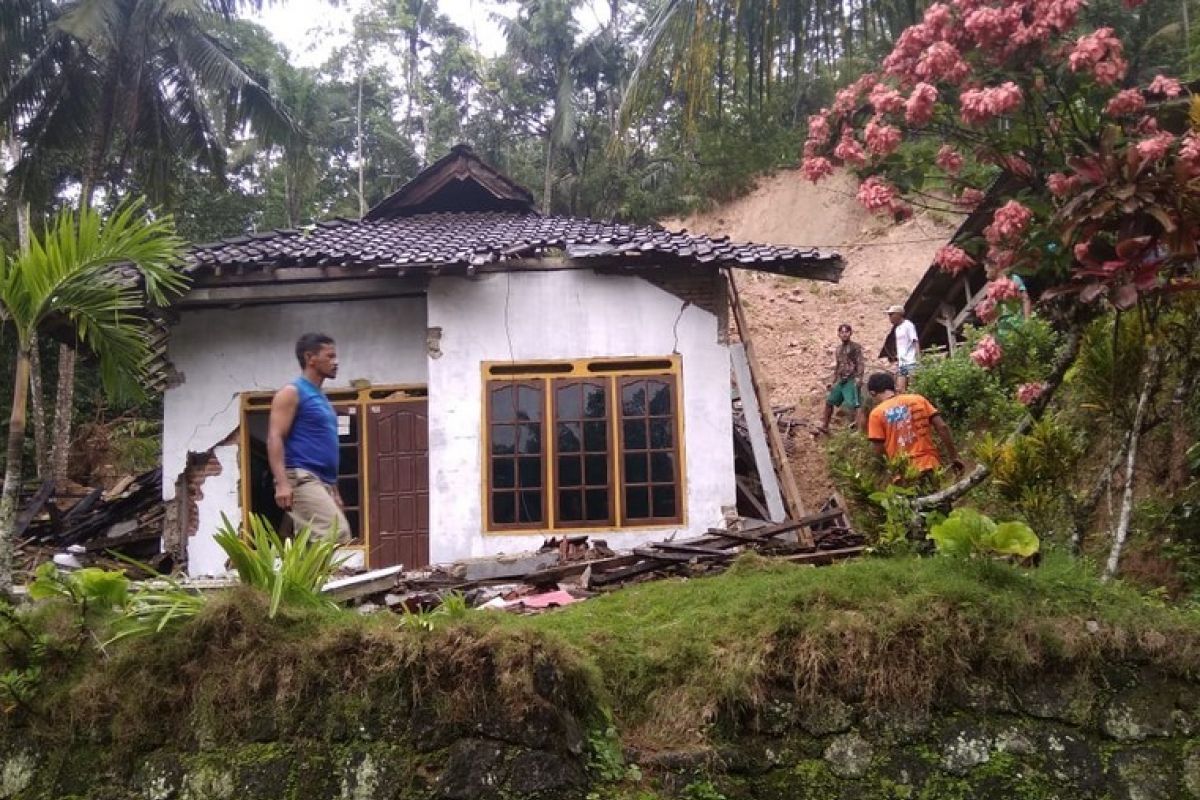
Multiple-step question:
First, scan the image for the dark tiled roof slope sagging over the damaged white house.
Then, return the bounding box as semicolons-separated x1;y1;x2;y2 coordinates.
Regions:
185;211;839;277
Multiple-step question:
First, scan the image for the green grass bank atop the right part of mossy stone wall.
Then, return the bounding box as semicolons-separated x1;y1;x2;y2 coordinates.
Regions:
500;555;1200;744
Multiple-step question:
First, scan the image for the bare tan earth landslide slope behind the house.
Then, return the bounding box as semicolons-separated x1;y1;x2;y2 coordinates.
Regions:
662;170;953;509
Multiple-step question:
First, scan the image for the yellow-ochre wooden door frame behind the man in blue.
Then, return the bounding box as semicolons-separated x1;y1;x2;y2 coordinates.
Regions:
238;384;430;570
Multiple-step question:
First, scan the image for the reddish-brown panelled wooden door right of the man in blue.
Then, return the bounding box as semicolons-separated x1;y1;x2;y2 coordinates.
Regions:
366;399;430;570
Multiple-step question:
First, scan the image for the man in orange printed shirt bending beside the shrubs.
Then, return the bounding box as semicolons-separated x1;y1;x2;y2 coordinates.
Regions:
866;372;962;477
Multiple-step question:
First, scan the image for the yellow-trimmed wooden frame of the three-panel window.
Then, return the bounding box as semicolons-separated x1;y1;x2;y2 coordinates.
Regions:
480;355;688;535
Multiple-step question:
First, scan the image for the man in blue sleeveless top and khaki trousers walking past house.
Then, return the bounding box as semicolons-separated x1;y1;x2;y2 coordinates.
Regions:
266;333;353;543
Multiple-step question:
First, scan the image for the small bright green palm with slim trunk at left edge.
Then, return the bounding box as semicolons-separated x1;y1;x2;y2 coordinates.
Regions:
0;201;186;590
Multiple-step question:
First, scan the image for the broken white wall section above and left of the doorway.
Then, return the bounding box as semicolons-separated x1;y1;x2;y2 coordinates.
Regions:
162;297;428;575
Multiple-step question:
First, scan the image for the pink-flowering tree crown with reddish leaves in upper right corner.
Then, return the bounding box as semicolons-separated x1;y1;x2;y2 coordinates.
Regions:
803;0;1200;328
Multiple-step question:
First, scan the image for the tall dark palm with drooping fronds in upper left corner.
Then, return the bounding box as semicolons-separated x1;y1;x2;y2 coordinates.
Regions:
0;0;293;479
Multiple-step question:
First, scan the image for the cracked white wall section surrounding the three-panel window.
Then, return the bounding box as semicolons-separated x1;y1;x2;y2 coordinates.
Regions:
428;270;736;563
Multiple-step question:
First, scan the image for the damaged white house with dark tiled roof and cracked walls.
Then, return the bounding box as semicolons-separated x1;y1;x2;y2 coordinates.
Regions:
163;146;841;575
